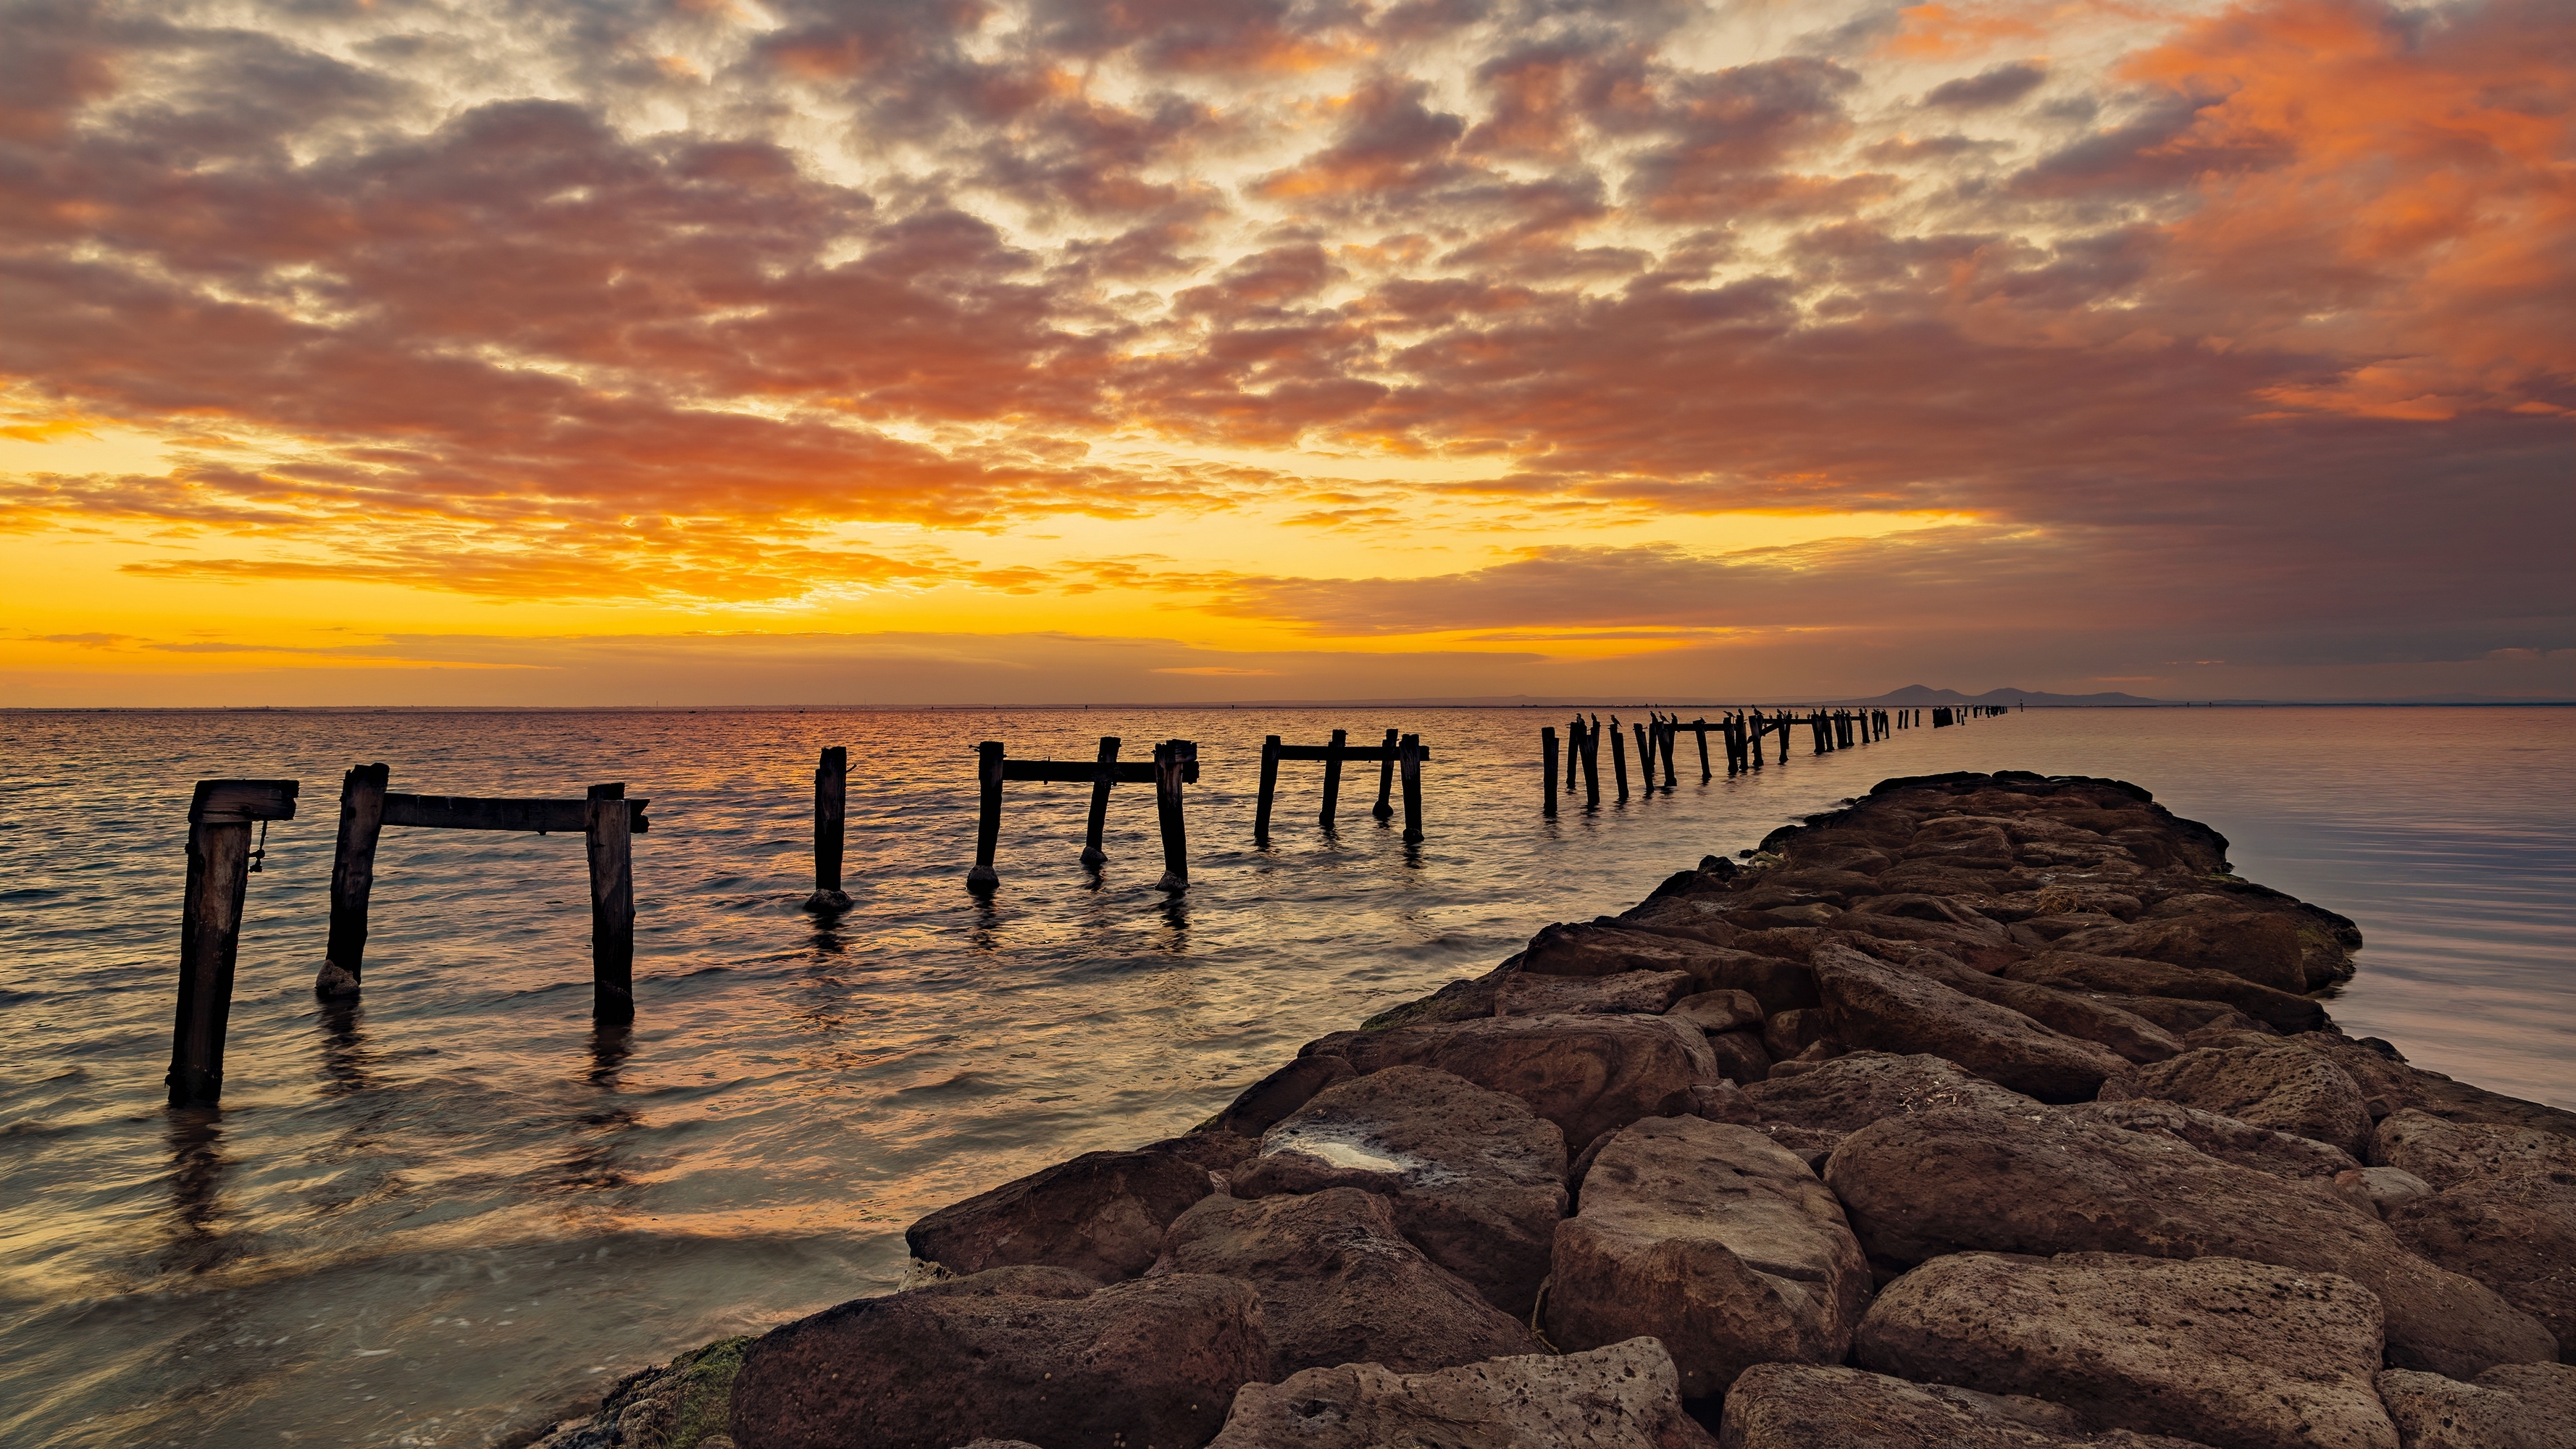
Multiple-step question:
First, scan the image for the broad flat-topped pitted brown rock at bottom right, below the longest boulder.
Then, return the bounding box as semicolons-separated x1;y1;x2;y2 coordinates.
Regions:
1852;1253;2399;1449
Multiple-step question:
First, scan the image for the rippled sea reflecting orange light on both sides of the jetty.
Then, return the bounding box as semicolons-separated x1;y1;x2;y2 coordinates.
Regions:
0;709;2576;1446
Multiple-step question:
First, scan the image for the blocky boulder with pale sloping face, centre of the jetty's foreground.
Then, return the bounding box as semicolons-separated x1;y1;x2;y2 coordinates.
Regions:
1546;1116;1870;1398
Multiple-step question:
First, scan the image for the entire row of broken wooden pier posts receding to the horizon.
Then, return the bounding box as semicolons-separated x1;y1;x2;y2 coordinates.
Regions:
170;706;2002;1106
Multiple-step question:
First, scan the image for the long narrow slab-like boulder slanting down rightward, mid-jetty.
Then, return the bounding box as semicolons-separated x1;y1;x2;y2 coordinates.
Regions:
1811;946;2128;1101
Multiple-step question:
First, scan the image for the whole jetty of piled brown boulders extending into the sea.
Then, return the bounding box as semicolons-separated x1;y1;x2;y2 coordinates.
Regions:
543;771;2576;1449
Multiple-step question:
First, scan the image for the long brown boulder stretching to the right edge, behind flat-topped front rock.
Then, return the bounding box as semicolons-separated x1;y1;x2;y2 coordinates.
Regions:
1824;1108;2558;1379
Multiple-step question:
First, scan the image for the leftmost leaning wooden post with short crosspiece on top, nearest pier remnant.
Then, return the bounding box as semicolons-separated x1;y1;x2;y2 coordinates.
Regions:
167;779;301;1106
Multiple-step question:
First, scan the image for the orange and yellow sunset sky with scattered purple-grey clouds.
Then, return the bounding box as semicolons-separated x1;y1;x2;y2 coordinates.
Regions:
0;0;2576;704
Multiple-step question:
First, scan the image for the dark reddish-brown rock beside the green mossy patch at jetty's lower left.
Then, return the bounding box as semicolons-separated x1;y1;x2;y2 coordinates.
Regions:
732;1274;1270;1449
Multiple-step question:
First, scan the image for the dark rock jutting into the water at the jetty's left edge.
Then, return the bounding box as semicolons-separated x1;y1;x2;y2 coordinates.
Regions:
904;1150;1210;1282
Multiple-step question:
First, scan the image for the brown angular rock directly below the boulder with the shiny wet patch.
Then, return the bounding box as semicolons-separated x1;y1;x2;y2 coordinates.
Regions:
1154;1189;1540;1379
